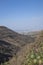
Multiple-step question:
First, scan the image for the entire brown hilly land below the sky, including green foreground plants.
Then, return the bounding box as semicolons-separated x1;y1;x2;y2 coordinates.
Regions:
0;26;43;65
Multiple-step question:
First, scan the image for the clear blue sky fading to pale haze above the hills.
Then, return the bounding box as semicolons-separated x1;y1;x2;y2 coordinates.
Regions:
0;0;43;31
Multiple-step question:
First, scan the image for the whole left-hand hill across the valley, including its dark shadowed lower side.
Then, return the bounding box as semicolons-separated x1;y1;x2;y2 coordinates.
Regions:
0;26;35;63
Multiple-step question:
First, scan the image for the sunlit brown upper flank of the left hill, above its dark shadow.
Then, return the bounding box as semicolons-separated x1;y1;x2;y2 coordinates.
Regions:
0;26;34;46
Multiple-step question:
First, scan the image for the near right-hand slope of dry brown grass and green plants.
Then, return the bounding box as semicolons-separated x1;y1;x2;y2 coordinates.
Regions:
0;27;43;65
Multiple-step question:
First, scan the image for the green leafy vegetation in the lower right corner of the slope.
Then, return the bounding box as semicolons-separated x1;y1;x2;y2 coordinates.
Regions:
22;43;43;65
